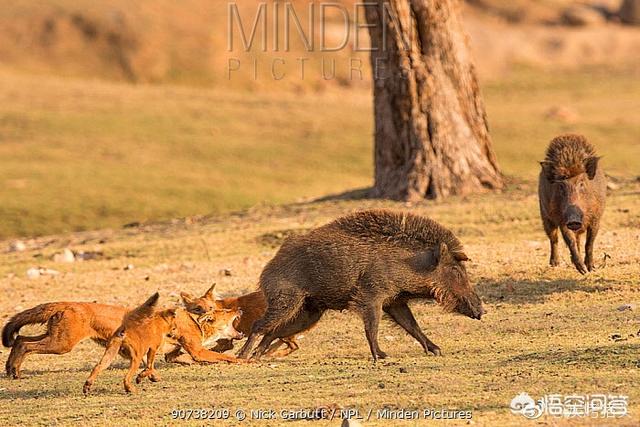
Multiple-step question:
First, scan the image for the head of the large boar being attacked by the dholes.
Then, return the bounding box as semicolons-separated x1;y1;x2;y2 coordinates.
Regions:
433;243;484;320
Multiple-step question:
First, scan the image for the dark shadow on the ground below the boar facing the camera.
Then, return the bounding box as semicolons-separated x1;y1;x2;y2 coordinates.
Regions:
476;279;615;304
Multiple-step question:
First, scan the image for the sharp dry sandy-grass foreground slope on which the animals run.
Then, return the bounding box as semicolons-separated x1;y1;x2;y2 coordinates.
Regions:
0;180;640;426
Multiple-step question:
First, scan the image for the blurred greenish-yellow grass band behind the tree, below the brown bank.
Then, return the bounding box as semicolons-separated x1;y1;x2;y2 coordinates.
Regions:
0;64;640;238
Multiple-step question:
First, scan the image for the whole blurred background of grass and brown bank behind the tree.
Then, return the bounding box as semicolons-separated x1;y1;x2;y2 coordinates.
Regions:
0;0;640;238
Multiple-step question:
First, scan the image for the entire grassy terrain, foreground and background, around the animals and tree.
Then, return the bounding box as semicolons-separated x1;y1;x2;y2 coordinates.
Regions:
0;0;640;427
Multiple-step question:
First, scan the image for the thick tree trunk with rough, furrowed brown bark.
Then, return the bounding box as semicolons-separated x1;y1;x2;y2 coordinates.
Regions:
365;0;503;201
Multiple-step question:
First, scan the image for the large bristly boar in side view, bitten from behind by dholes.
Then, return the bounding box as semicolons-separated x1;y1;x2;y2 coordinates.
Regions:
239;211;484;360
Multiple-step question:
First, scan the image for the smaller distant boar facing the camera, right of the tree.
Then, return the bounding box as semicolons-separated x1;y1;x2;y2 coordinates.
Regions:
538;134;607;274
